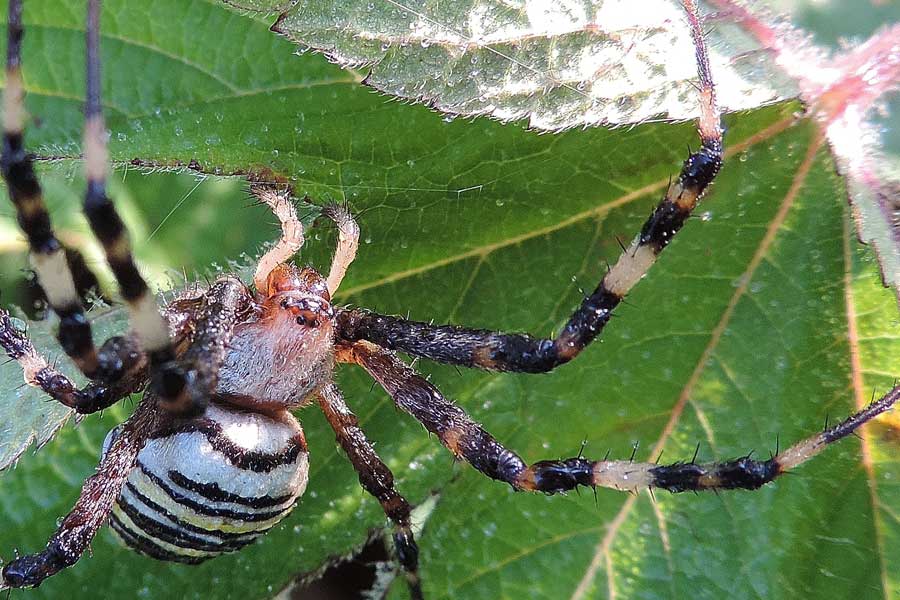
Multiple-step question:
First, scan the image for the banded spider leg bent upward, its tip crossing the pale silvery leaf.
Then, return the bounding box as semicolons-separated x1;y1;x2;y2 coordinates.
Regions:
338;0;723;373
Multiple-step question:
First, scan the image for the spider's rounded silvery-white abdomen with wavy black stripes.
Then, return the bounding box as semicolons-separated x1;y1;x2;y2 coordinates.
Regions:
104;405;309;563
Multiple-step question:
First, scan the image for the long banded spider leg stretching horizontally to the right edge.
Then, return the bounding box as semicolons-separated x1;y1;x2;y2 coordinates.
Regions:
338;342;900;494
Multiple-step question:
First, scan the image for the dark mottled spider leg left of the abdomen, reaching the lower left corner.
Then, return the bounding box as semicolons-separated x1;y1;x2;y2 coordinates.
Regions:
0;398;160;589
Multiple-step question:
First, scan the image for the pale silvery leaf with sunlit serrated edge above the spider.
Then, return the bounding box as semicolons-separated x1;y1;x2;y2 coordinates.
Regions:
256;0;796;130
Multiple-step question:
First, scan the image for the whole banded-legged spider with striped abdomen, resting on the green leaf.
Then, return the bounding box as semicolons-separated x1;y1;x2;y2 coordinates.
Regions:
0;0;900;598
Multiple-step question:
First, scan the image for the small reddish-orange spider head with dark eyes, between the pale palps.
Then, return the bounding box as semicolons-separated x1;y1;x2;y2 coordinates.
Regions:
263;263;334;328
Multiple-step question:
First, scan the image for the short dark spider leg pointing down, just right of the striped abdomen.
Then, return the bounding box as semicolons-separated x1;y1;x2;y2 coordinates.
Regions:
319;384;423;600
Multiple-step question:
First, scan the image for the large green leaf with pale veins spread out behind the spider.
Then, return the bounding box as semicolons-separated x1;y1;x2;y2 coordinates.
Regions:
0;0;900;600
